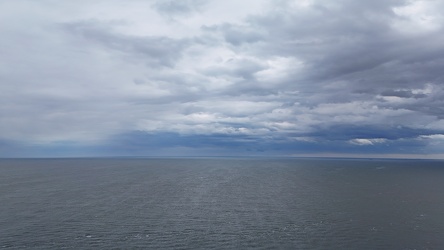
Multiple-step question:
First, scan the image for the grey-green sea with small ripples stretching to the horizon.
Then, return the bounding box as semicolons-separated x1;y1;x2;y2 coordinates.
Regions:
0;159;444;249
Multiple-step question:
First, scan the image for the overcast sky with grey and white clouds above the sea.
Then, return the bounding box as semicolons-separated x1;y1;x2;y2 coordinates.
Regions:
0;0;444;158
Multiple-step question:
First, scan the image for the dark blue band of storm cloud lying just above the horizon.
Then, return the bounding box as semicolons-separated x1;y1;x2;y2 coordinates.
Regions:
102;128;440;156
